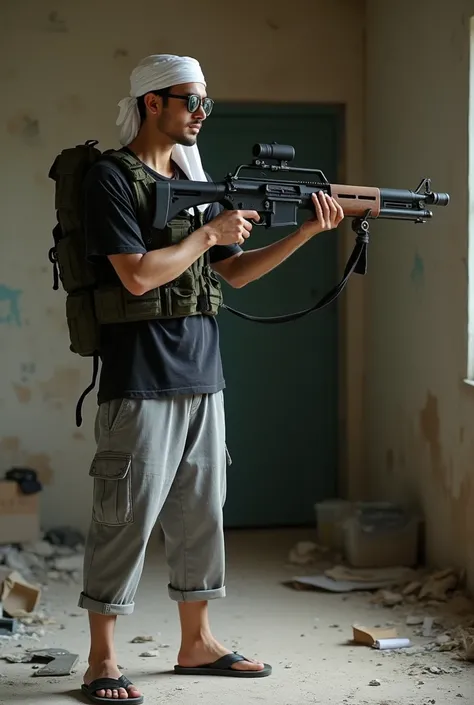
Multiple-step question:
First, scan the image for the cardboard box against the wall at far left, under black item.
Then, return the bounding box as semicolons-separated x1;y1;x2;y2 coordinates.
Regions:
0;480;40;544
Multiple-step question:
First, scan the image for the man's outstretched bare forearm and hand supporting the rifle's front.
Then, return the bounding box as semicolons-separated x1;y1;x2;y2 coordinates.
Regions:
213;192;344;289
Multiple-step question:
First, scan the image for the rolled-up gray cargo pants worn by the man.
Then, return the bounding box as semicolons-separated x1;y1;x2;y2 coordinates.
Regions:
79;392;227;615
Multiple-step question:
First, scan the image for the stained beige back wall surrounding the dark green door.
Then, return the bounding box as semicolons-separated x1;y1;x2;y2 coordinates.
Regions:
0;0;366;528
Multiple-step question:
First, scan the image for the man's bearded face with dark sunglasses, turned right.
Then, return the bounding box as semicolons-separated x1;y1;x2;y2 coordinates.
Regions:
147;83;207;147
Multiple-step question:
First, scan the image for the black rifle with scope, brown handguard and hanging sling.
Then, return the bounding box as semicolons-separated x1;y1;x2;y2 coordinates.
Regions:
153;142;450;323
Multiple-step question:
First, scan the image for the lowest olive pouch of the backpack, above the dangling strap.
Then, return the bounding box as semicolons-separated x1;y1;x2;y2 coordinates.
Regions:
66;291;100;357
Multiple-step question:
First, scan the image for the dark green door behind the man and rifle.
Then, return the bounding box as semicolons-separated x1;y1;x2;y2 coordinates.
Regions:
199;104;341;527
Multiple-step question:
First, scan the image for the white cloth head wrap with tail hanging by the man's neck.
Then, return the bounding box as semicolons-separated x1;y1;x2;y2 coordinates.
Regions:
116;54;207;210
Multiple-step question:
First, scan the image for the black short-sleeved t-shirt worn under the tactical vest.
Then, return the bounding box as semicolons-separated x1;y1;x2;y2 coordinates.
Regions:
83;147;240;404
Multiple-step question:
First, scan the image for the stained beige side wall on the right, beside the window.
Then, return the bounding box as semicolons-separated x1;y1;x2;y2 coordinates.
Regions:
366;0;474;587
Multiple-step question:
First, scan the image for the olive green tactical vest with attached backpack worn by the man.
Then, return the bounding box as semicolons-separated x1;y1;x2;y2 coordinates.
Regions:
49;141;222;364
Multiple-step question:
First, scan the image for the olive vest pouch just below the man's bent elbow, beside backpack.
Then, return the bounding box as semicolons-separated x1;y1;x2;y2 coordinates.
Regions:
94;286;162;324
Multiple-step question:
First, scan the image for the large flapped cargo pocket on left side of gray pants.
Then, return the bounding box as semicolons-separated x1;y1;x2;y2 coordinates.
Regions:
89;451;133;526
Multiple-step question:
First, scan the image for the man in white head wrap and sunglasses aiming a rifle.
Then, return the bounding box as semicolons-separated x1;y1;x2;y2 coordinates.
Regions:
79;55;343;703
